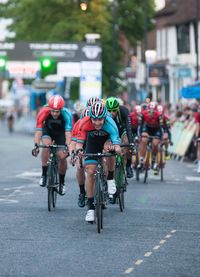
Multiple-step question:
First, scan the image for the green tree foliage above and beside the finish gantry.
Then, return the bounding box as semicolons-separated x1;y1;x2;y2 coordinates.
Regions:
0;0;154;94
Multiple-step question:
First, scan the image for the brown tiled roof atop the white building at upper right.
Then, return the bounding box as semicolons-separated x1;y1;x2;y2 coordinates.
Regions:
155;0;197;25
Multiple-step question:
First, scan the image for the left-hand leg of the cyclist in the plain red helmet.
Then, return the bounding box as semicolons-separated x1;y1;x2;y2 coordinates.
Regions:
40;133;52;187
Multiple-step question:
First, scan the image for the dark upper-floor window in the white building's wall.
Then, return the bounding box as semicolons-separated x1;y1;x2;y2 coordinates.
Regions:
176;24;190;54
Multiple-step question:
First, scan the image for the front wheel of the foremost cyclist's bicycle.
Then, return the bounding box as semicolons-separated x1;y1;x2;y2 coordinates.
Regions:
96;174;103;233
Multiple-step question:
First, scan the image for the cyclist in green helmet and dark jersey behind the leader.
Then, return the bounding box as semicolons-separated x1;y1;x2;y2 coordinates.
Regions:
106;97;133;178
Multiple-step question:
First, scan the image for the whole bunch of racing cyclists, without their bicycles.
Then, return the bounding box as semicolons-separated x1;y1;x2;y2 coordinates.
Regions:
32;95;171;222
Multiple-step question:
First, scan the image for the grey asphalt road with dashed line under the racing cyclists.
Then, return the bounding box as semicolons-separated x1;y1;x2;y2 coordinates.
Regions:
0;121;200;277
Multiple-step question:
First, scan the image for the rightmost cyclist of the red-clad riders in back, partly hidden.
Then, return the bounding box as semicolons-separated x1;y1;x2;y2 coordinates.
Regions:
157;105;172;160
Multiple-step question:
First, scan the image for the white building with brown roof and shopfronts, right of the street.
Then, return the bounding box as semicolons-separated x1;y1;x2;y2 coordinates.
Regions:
152;0;200;105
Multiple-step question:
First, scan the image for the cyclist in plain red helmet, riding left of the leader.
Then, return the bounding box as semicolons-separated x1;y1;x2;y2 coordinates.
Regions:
33;95;72;195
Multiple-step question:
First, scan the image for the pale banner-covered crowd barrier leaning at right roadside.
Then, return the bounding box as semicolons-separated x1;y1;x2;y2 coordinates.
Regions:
169;120;195;158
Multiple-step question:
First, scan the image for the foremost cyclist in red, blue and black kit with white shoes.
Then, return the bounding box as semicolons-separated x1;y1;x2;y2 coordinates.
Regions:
76;101;121;222
